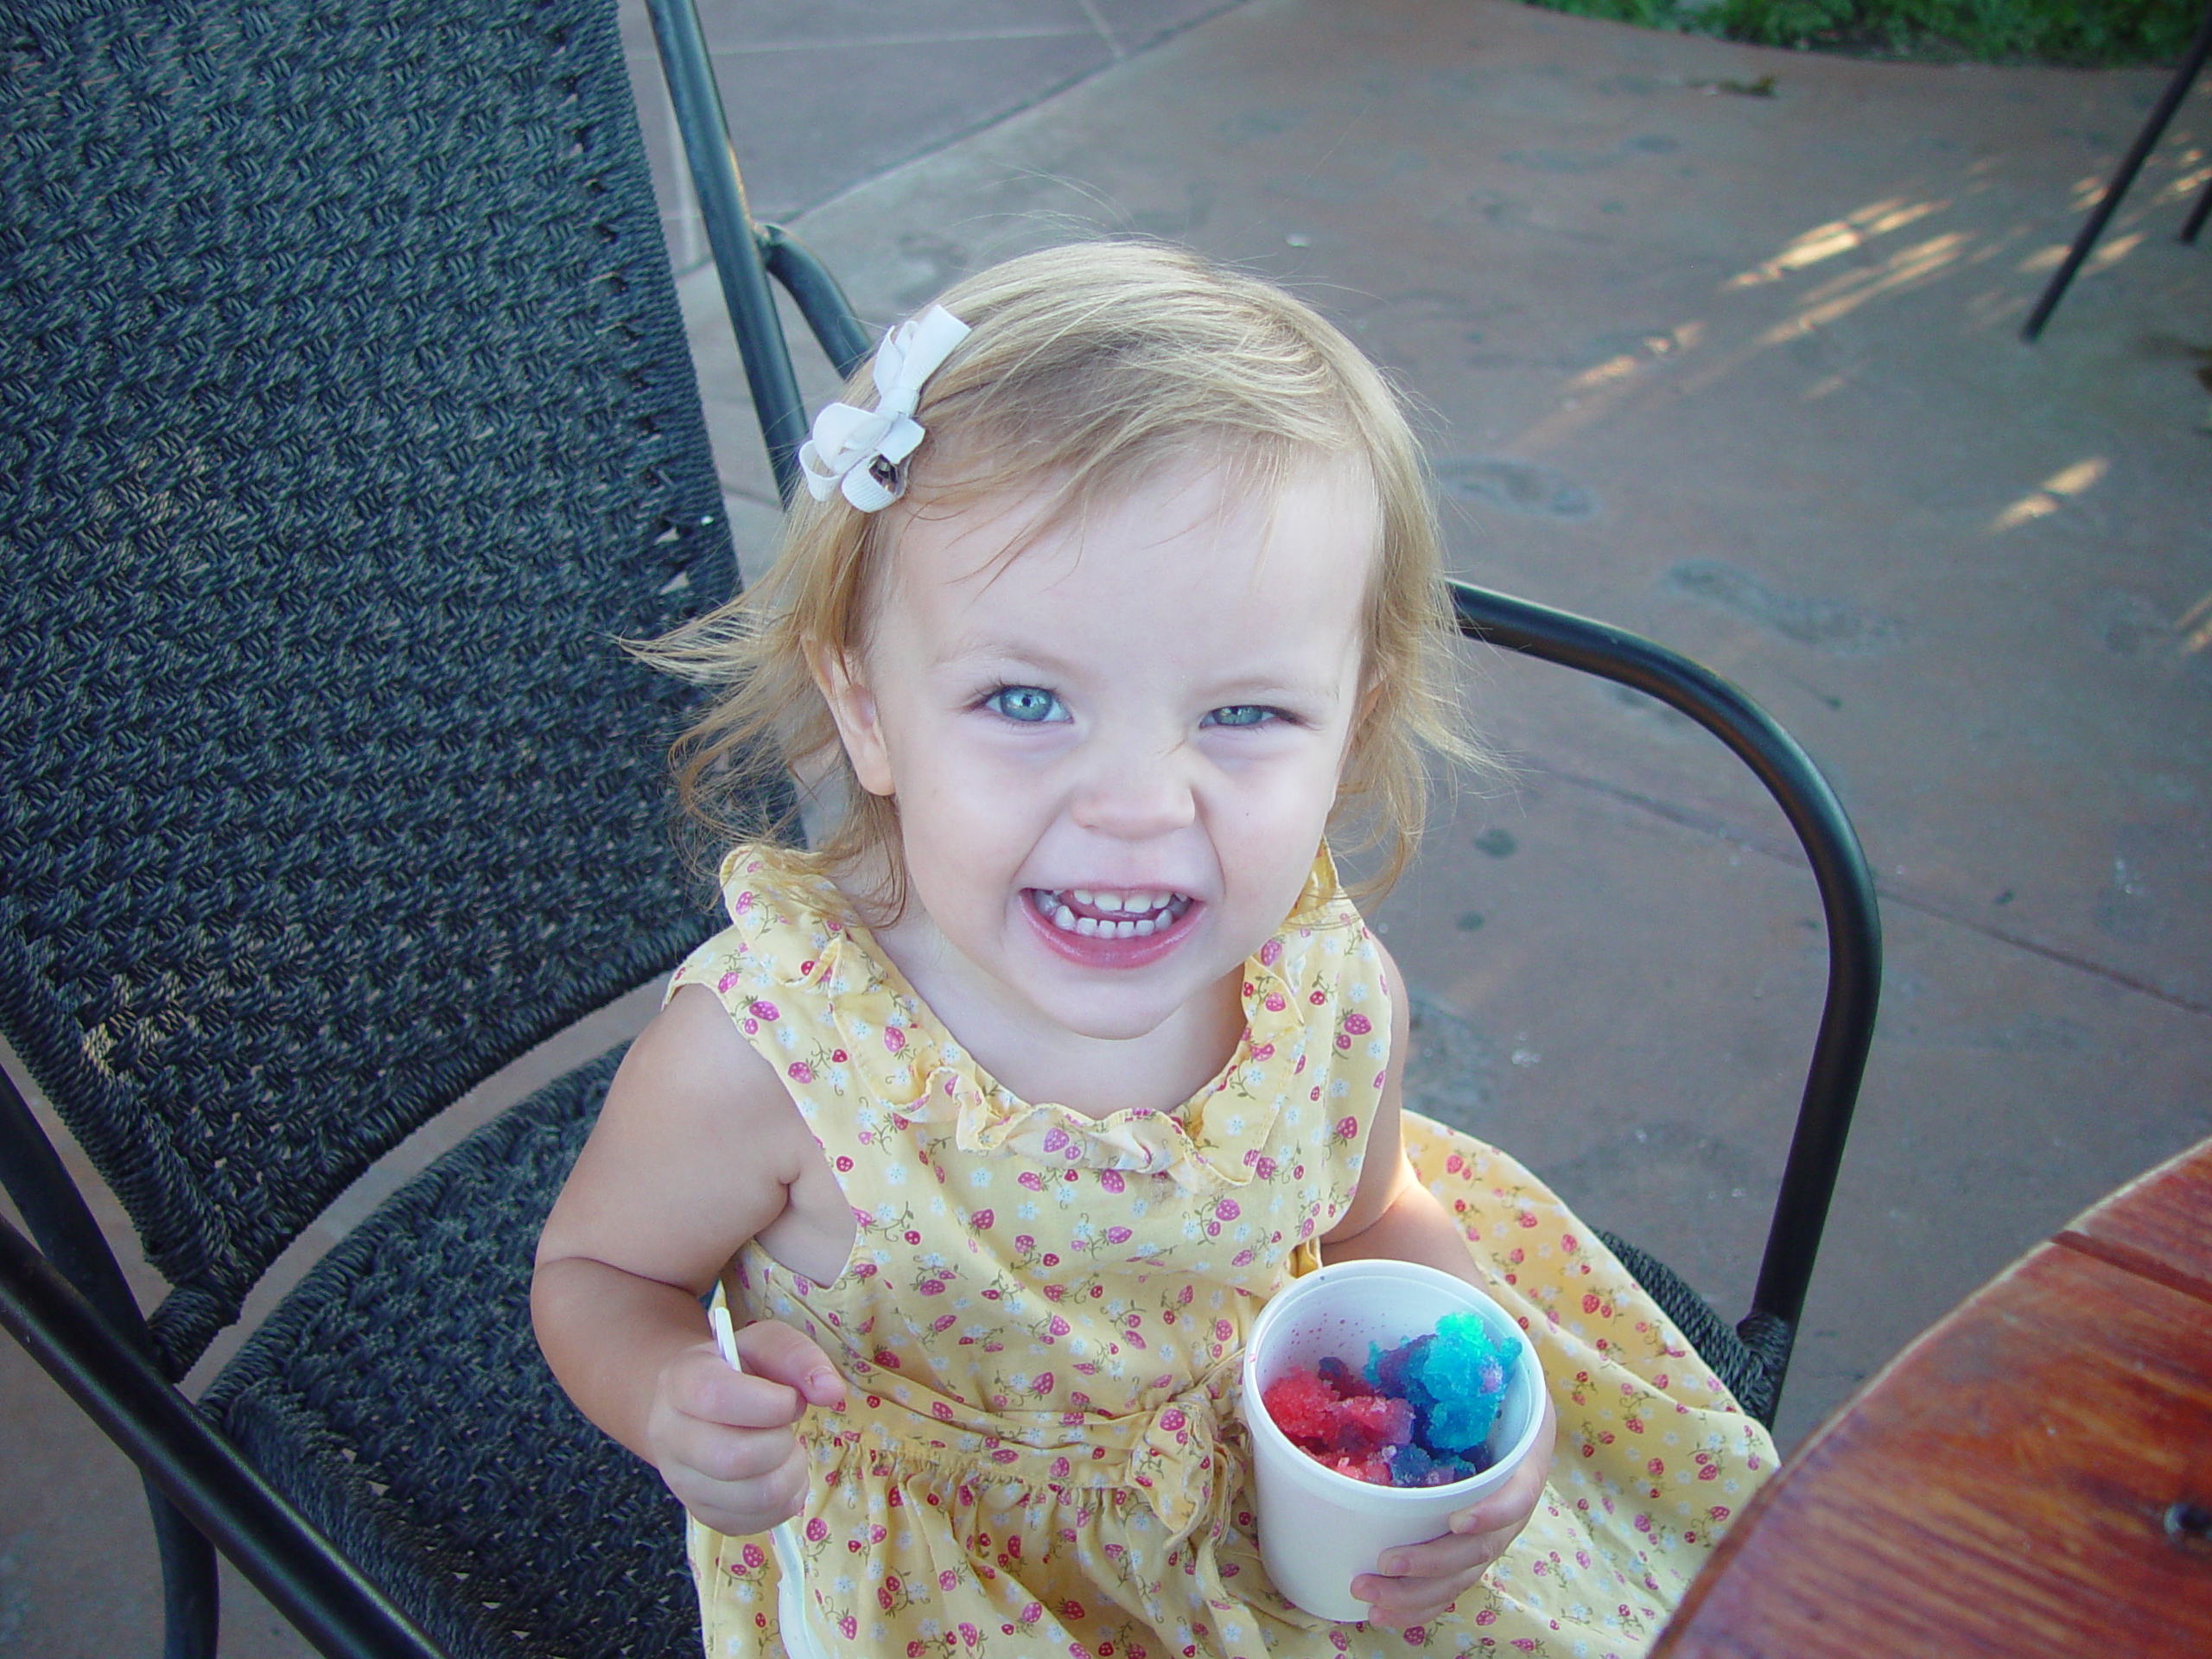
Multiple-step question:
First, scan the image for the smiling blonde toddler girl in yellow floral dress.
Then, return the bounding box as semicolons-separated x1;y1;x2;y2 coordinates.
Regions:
533;244;1774;1659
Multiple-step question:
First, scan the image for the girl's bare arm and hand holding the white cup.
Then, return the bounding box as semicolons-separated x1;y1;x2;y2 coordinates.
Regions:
1320;943;1555;1628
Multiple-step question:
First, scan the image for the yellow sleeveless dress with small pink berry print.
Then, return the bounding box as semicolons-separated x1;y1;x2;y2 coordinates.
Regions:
671;847;1774;1659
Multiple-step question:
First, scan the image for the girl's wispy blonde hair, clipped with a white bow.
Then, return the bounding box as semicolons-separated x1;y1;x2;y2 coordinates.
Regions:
632;241;1482;913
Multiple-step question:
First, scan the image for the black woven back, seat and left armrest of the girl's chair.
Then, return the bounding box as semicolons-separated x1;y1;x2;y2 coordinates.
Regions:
0;0;772;1659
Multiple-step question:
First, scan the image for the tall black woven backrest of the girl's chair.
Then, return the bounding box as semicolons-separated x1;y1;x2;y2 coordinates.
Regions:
0;0;752;1376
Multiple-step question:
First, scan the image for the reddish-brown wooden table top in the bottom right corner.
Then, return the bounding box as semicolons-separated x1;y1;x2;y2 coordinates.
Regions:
1652;1139;2212;1659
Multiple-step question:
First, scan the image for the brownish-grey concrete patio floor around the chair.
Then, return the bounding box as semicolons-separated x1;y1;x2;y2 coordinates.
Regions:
0;0;2212;1659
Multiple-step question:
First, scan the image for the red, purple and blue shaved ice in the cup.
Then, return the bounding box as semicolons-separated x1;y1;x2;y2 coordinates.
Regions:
1261;1314;1520;1486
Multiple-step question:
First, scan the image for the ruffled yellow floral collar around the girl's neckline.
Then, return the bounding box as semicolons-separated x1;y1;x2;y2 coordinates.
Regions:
726;847;1354;1192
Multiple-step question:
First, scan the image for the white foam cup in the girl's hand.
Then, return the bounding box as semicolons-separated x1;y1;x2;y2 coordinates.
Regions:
1243;1261;1544;1621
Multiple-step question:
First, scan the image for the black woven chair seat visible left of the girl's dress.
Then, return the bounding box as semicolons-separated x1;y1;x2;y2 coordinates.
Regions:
204;1051;699;1659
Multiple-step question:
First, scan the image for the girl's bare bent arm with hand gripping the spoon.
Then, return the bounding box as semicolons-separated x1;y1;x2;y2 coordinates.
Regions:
531;987;842;1533
